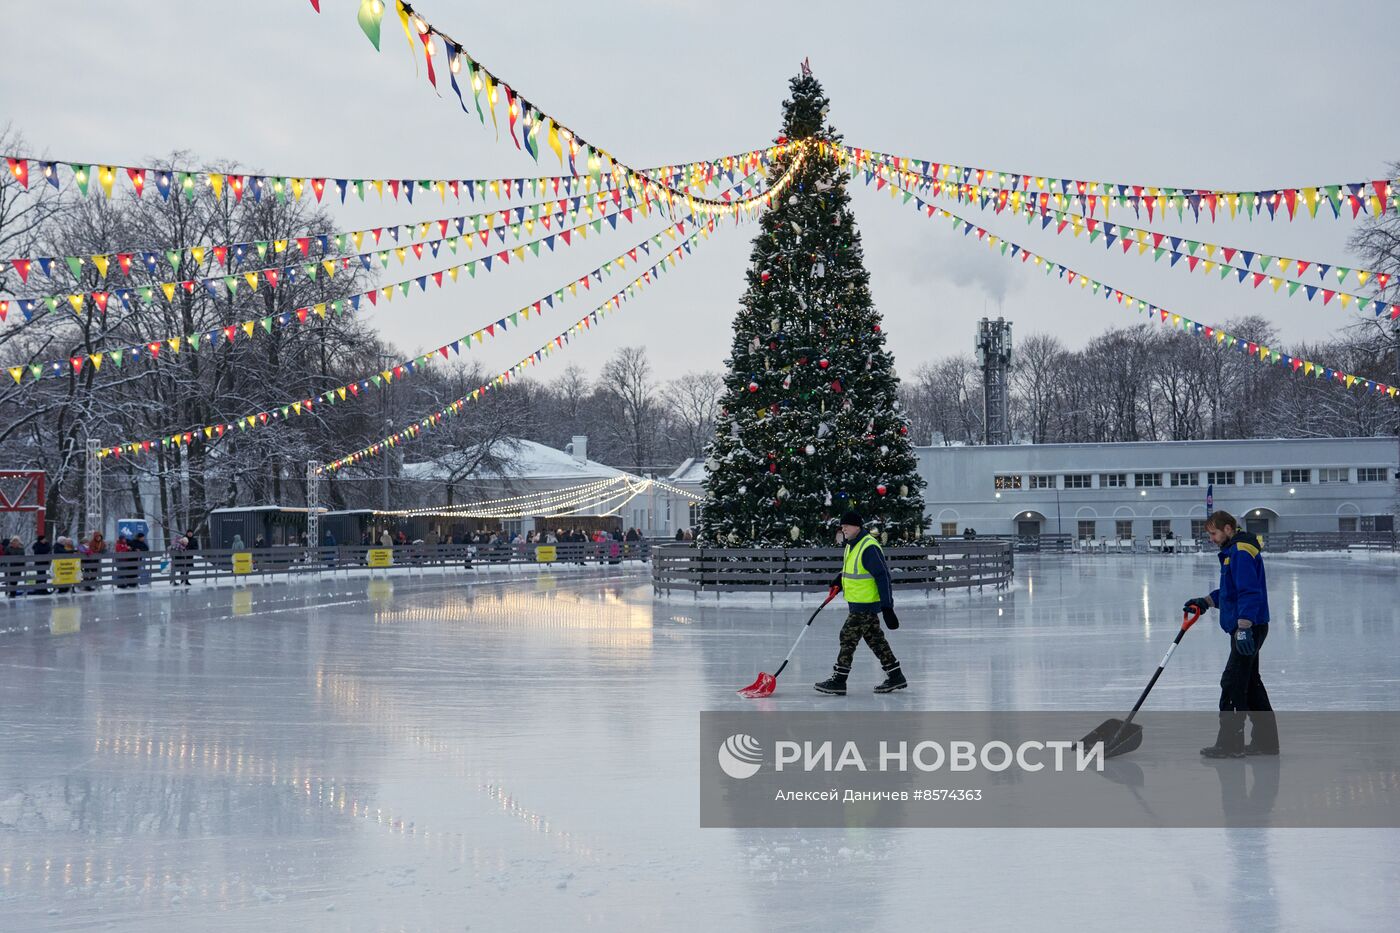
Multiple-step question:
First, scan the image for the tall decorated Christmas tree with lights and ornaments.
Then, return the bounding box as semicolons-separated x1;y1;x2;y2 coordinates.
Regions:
699;63;924;546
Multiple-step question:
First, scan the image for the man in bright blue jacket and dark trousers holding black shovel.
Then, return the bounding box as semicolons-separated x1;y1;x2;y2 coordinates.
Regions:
1183;511;1278;758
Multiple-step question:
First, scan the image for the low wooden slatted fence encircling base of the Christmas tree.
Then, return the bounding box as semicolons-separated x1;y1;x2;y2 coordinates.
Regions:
651;539;1015;594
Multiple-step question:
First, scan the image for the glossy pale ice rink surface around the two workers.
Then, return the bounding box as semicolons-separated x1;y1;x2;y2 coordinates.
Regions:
0;555;1400;933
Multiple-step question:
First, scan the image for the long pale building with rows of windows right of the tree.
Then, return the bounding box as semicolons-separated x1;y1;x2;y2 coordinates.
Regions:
916;437;1400;541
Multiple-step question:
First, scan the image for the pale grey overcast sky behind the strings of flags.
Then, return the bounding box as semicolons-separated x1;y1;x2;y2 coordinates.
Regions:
0;0;1400;378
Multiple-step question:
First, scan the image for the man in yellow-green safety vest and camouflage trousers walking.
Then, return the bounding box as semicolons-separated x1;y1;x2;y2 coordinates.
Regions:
815;511;909;696
